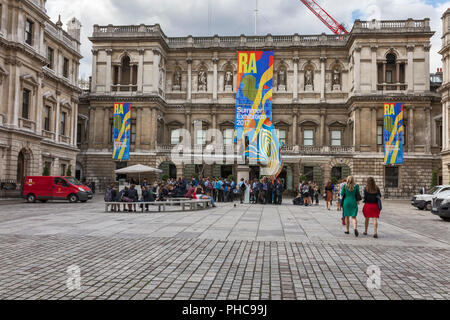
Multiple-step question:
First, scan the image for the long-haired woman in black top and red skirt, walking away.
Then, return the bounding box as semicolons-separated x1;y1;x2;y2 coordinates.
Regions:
363;177;381;238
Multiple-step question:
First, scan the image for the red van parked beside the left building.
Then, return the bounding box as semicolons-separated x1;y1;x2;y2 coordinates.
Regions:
22;176;93;203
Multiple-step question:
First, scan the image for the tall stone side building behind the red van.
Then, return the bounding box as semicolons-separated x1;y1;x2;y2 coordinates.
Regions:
0;0;82;189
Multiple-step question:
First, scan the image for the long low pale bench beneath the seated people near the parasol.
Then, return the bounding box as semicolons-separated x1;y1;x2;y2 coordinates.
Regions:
105;198;211;212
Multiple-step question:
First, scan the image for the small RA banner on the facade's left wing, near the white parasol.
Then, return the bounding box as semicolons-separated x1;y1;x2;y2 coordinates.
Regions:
113;103;131;160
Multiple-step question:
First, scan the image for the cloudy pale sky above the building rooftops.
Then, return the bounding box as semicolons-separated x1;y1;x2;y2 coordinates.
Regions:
47;0;450;78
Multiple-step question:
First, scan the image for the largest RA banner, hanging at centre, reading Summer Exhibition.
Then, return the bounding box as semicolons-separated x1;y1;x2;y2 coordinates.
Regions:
235;51;281;176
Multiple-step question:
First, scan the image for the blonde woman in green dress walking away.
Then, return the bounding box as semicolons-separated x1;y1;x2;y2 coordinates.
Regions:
341;176;361;237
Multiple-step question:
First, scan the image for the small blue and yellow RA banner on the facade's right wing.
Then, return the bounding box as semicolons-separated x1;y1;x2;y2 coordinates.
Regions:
384;103;404;164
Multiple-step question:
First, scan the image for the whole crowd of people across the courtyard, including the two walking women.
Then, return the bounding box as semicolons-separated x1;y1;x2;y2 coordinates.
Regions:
105;176;382;238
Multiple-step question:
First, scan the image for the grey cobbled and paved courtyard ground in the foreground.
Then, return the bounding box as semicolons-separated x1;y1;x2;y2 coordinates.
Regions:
0;199;450;299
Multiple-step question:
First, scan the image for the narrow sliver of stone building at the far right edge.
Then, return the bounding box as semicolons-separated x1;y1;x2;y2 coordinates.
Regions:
439;9;450;184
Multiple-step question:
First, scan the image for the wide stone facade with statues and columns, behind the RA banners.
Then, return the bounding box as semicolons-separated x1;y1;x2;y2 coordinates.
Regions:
78;19;442;197
